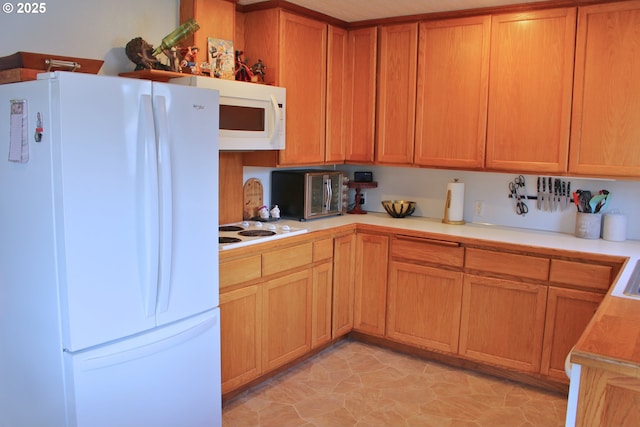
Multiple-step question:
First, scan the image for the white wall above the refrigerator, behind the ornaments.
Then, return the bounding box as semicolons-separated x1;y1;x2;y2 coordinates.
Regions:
0;0;180;75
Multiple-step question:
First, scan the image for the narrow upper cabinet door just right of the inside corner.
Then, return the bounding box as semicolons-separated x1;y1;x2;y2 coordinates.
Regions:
344;27;378;163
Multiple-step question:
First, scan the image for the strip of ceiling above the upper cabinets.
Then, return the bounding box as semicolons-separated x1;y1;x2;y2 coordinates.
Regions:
238;0;547;22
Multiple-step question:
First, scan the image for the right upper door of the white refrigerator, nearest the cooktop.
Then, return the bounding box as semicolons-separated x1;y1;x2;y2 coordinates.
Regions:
153;83;219;324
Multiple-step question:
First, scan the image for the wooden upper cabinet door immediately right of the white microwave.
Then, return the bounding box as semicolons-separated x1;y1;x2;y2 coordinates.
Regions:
278;12;327;165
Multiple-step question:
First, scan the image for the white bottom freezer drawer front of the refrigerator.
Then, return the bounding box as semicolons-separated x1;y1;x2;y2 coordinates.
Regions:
65;309;222;427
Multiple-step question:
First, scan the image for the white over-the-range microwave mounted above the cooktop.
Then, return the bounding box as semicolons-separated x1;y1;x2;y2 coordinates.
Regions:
170;76;287;151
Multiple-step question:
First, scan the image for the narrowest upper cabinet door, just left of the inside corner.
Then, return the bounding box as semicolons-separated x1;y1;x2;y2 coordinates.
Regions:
325;25;348;163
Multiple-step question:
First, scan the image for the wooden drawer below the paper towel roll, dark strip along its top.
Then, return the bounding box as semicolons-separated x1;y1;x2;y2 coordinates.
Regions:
391;236;464;268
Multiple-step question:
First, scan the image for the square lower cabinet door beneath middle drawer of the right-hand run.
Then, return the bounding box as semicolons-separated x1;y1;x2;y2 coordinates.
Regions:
459;274;547;372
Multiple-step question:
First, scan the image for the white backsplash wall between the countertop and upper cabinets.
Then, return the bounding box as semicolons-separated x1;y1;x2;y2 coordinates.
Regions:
244;165;640;240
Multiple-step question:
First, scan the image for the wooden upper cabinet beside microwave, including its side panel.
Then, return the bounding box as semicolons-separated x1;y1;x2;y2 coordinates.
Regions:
244;9;327;166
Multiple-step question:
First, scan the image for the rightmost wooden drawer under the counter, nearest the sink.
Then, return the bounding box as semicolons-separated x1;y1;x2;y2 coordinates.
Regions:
549;259;613;292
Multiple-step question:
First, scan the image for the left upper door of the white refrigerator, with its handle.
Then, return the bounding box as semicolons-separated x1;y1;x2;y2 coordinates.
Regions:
52;72;159;351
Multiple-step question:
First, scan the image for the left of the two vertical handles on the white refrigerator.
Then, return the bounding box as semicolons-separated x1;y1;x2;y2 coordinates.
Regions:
137;95;159;317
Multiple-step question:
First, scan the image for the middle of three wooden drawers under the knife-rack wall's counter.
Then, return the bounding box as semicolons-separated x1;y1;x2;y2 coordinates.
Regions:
465;248;549;281
